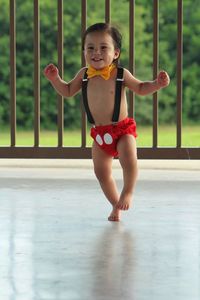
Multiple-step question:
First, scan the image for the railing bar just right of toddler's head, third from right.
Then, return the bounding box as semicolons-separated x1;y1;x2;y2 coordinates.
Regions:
129;0;135;117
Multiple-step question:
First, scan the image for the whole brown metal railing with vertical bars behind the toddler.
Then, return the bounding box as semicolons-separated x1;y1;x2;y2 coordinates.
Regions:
0;0;200;159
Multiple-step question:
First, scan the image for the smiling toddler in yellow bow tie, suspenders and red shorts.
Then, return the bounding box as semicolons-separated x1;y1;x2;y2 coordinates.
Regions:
44;23;170;221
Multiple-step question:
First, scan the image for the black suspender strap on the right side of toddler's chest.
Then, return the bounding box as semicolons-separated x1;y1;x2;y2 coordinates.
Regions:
112;67;124;122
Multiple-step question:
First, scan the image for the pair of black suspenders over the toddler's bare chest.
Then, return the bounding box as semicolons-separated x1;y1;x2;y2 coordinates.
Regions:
82;67;124;124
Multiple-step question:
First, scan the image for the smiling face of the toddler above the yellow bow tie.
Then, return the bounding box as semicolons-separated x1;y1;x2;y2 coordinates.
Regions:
84;32;120;70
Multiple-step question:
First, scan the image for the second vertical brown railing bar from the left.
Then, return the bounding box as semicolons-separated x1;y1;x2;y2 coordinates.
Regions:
34;0;40;147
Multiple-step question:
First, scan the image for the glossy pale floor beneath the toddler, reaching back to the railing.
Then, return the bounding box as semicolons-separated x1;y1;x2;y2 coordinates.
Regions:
0;164;200;300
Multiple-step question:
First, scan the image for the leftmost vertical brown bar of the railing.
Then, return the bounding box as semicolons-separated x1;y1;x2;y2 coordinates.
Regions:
10;0;16;147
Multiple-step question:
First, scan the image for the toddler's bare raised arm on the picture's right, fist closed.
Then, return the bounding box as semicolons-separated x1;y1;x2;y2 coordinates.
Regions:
124;69;170;95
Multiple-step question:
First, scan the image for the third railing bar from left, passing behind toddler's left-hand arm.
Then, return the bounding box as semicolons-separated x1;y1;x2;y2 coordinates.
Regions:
57;0;64;147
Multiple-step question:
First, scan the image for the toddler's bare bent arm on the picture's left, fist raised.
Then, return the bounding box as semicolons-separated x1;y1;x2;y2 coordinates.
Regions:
44;64;85;97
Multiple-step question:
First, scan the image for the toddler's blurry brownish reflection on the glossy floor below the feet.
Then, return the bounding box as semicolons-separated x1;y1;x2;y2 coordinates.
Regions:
91;223;134;300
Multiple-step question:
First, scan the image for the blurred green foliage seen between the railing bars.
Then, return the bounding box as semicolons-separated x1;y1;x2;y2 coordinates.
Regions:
0;0;200;129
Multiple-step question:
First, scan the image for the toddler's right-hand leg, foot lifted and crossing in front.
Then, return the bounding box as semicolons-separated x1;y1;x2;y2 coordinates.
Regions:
117;135;138;210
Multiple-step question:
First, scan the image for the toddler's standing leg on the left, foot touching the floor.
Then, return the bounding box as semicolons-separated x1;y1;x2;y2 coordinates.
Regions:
92;142;120;221
